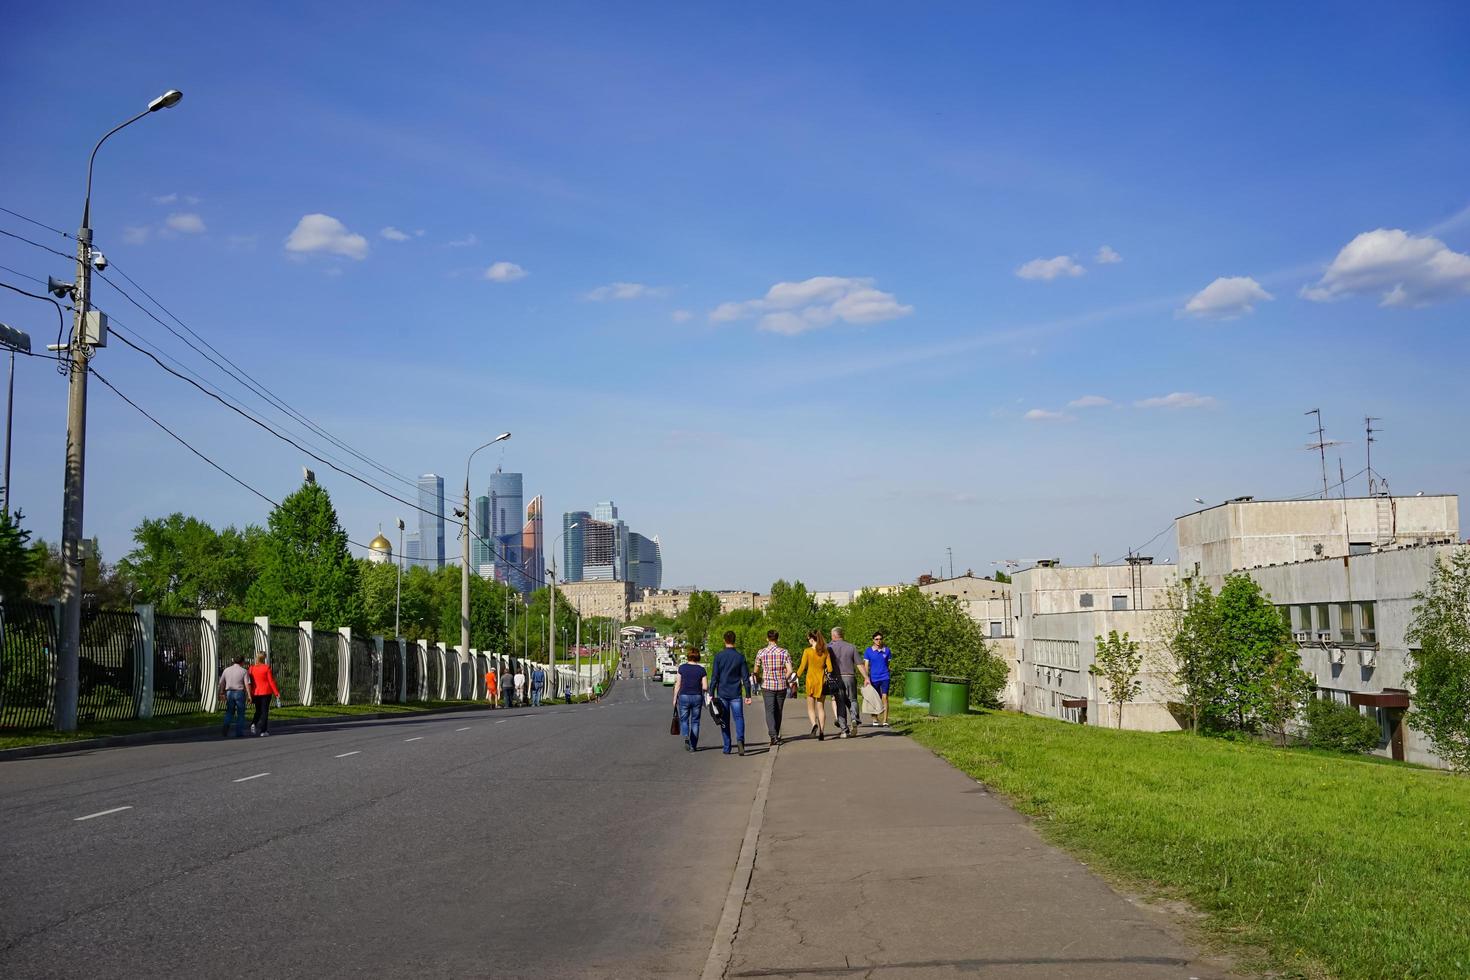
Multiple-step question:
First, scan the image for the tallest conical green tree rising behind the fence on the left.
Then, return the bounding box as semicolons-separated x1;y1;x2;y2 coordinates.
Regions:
245;482;363;629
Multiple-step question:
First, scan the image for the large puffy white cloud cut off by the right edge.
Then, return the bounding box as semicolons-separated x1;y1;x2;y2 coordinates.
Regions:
1301;228;1470;306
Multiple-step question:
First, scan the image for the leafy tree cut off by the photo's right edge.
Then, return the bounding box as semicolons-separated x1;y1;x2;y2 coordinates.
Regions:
1405;548;1470;771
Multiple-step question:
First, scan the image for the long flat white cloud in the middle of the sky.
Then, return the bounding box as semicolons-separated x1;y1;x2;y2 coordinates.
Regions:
710;276;913;335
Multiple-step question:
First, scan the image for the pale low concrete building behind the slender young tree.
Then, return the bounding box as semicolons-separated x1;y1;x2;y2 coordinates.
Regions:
1004;558;1180;732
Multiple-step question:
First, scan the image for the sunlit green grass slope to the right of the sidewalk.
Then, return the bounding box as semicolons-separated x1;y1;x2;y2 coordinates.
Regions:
894;708;1470;977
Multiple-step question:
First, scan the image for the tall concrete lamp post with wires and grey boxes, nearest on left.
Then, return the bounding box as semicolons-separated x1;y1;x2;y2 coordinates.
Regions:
53;88;184;732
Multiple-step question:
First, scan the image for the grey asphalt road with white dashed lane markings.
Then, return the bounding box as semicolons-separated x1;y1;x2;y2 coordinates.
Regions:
0;646;763;979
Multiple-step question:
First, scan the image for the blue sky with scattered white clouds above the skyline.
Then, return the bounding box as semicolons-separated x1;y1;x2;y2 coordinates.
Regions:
0;3;1470;589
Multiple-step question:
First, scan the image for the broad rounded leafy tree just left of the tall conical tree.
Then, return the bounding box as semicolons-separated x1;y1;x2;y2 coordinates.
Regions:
118;513;263;619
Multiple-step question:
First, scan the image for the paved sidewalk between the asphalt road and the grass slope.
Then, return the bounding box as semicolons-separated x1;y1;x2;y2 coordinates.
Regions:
725;729;1230;980
